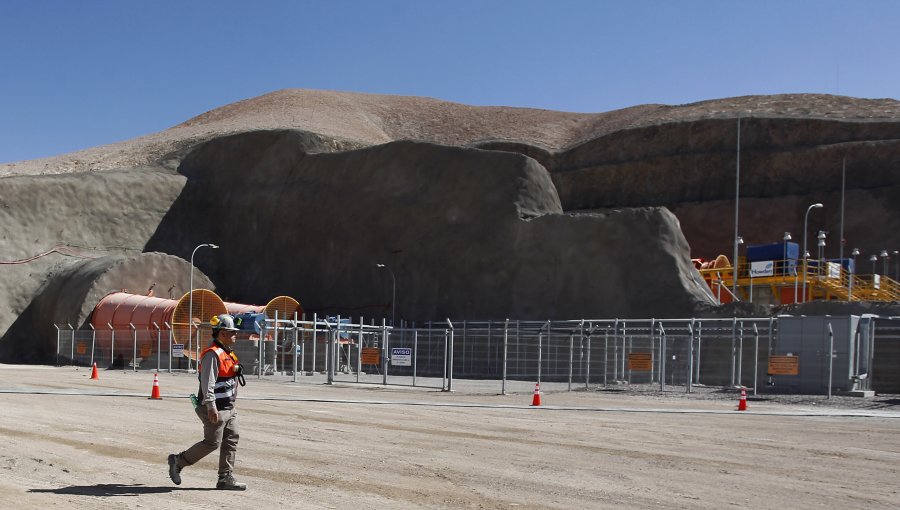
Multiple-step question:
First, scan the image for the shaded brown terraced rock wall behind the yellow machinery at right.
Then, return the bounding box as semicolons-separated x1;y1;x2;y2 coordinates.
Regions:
546;118;900;259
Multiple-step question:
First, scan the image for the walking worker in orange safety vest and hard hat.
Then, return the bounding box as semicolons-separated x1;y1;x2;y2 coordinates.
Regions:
169;314;247;491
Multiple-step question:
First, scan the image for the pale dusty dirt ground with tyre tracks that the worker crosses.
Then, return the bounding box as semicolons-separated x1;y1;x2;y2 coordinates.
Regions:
0;365;900;509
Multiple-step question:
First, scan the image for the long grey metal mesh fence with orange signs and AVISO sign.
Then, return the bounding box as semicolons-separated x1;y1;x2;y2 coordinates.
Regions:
56;316;900;393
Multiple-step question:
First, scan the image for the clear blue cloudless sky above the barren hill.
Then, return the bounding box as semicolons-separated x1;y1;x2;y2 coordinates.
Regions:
0;0;900;162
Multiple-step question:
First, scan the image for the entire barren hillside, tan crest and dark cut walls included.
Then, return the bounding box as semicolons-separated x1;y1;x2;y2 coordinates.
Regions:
0;90;900;360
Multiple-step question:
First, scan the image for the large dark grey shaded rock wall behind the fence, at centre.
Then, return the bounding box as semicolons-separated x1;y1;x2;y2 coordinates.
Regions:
147;131;709;321
